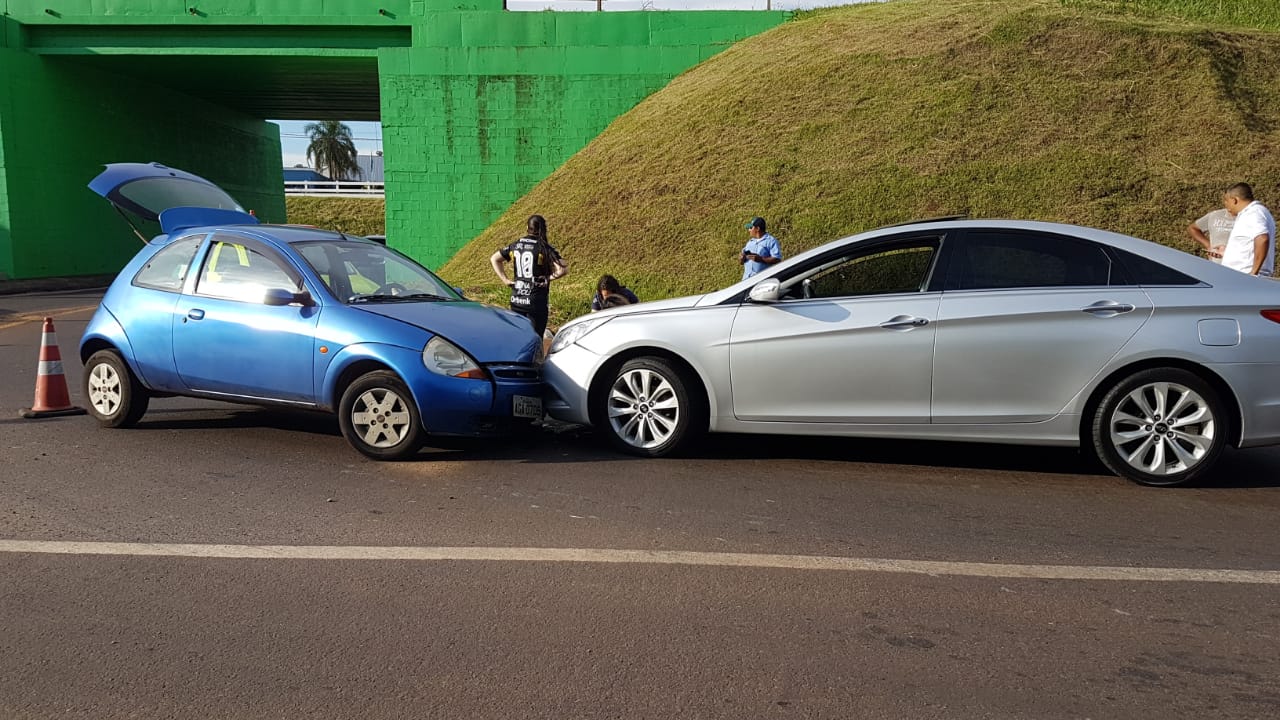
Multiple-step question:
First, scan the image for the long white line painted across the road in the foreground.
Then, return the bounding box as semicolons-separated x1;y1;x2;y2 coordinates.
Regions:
0;539;1280;585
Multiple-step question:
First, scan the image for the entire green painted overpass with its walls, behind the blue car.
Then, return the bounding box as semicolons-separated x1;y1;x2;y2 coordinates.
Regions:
0;0;786;282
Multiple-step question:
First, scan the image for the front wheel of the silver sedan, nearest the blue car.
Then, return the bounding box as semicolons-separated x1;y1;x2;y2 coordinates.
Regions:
593;357;707;457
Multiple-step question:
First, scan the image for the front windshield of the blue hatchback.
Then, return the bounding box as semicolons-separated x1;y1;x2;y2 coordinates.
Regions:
294;238;462;304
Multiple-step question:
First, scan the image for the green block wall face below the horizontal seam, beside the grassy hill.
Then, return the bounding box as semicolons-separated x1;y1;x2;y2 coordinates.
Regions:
383;50;671;266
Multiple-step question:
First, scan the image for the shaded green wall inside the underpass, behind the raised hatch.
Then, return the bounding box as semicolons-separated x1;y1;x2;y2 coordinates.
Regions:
0;49;284;279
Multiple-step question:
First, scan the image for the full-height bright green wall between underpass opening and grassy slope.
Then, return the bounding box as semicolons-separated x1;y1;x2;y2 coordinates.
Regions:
379;12;785;266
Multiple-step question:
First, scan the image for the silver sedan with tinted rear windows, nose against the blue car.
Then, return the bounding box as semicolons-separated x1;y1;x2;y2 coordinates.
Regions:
545;219;1280;486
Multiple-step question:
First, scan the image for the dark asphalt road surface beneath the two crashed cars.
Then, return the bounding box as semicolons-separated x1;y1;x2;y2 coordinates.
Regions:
0;288;1280;719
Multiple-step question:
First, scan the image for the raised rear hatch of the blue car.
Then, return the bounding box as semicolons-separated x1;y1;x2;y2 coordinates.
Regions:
88;163;257;233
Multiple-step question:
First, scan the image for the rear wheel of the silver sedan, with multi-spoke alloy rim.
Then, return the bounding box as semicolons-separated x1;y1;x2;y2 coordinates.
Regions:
1092;368;1228;487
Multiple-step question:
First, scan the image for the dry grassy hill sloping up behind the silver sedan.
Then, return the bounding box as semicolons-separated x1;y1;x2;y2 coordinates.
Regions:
442;0;1280;325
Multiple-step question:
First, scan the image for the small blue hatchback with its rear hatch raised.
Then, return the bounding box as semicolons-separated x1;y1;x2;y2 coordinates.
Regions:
79;163;543;460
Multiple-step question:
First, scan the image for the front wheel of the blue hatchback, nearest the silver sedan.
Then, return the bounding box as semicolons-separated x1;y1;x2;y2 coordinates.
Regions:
338;370;425;460
